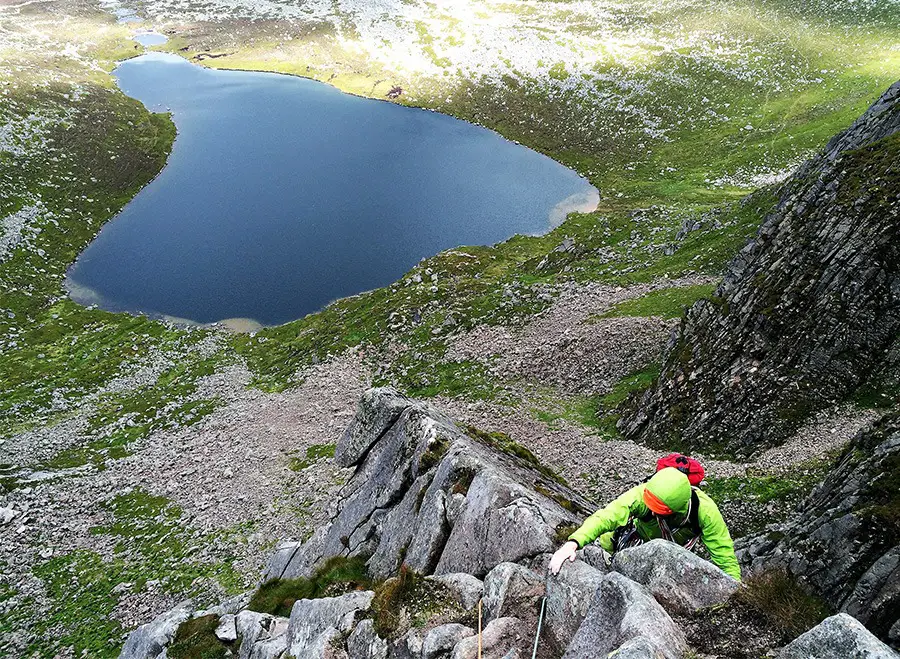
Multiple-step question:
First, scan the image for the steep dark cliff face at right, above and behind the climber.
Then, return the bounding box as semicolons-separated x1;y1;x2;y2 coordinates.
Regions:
620;82;900;454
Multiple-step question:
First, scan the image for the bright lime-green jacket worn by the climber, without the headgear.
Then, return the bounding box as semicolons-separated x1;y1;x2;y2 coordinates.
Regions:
569;470;741;581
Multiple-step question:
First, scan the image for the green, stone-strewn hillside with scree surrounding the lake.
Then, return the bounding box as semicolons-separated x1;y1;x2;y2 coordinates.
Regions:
0;0;900;657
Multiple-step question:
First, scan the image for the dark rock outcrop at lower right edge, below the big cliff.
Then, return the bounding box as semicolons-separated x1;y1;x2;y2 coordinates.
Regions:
738;414;900;642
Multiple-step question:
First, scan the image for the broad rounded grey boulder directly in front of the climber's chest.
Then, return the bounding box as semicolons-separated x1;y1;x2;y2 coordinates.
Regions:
612;540;739;613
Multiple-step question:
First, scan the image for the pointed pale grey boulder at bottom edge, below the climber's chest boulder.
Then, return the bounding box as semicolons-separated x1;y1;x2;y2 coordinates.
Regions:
563;572;687;659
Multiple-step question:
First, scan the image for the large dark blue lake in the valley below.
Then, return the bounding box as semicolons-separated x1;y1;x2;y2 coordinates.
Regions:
68;54;596;325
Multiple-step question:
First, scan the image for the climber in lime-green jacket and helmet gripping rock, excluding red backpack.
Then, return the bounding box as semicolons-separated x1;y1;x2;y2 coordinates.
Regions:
550;467;741;581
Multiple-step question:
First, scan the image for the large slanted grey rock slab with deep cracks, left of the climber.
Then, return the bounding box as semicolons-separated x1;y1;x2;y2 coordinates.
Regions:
278;389;592;578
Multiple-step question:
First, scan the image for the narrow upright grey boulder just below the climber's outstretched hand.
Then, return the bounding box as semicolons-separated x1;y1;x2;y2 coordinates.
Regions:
544;560;605;651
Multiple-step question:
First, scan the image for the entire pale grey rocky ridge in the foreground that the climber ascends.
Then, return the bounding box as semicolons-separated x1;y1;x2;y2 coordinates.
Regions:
121;389;894;659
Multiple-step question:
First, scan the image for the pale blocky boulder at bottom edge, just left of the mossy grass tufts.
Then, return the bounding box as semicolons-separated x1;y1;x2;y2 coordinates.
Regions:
287;591;375;659
